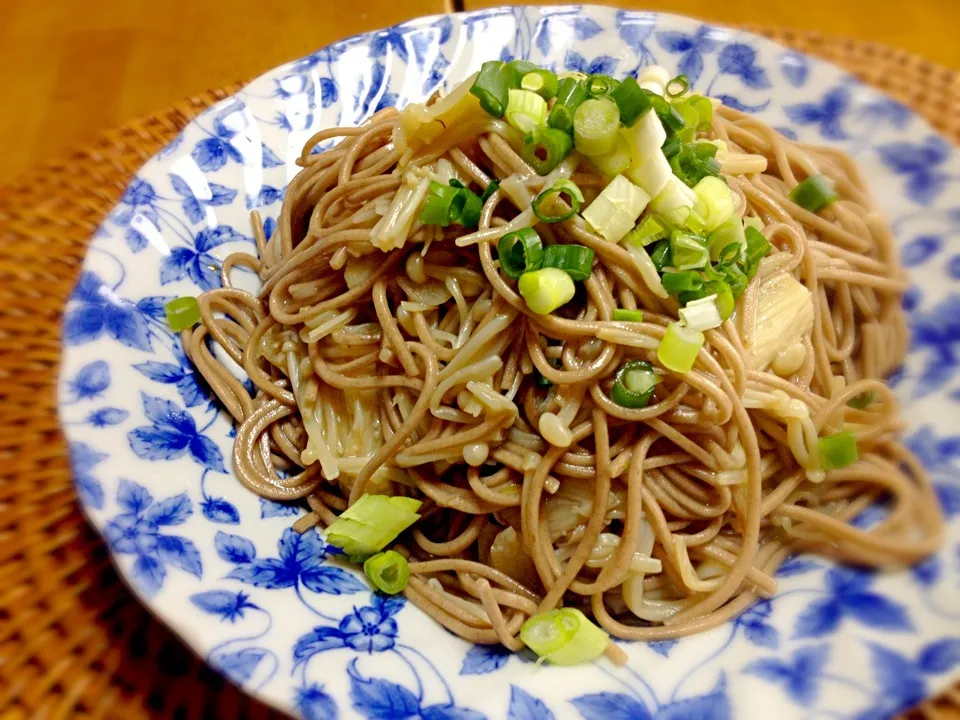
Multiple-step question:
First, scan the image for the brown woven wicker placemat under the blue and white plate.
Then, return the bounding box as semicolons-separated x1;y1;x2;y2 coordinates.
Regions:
0;28;960;720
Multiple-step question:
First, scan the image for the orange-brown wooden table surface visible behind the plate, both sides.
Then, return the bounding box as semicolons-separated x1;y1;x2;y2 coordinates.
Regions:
0;0;960;184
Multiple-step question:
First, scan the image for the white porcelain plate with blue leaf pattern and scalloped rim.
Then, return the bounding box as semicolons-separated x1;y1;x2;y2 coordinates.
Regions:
60;6;960;720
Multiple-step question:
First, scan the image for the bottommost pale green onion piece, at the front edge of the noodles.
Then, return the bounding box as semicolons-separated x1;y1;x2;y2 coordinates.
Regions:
520;608;610;665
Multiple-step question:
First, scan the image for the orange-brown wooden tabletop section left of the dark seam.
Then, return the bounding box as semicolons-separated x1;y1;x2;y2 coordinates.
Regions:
0;0;453;184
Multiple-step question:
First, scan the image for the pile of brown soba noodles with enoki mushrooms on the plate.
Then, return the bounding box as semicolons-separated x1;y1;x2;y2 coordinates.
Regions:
182;76;942;650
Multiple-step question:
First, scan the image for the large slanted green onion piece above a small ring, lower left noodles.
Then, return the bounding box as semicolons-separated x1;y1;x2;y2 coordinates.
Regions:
326;495;420;558
